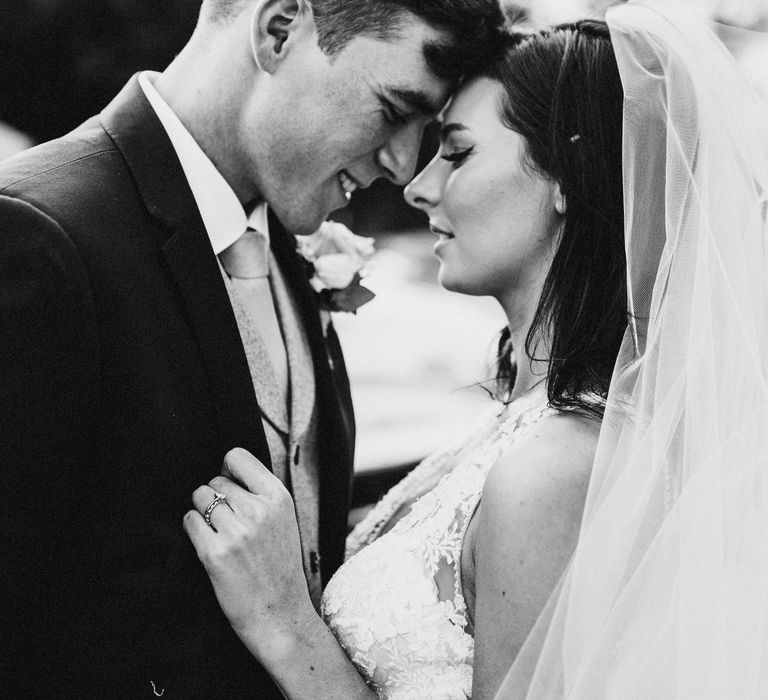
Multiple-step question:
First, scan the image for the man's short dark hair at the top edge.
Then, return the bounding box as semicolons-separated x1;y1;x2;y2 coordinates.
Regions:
312;0;503;82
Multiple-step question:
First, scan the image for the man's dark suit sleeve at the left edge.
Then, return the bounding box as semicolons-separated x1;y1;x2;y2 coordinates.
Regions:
0;196;98;677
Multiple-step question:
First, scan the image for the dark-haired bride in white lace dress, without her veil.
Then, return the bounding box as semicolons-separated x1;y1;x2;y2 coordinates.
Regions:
185;16;626;699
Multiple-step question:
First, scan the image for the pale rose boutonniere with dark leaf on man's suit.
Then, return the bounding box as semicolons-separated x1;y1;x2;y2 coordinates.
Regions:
296;221;376;313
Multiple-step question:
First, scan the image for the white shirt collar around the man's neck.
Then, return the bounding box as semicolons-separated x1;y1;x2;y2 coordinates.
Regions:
139;71;269;255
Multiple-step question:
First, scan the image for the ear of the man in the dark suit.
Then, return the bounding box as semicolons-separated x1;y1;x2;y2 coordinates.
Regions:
251;0;313;73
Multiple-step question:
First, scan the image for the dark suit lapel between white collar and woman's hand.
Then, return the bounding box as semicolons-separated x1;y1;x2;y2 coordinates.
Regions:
101;76;270;467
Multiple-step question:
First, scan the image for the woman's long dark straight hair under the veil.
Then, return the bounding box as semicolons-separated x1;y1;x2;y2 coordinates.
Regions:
488;20;627;414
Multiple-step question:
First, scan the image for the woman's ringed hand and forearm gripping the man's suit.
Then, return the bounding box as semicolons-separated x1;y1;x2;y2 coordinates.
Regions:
184;449;376;700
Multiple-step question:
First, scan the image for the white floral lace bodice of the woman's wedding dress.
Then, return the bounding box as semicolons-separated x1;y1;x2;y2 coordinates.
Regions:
321;399;554;700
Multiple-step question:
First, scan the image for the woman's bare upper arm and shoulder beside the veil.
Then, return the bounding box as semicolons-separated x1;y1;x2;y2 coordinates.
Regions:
466;414;600;700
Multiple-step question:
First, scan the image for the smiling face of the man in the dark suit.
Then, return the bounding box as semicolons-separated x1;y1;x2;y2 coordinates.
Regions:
246;13;449;234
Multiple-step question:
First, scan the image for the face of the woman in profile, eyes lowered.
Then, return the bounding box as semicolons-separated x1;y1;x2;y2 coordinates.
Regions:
405;78;561;308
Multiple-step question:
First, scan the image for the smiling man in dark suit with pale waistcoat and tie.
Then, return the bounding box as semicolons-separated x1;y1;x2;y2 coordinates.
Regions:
0;0;499;698
